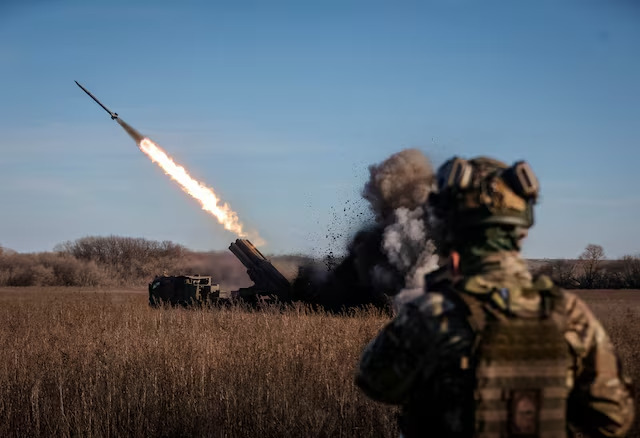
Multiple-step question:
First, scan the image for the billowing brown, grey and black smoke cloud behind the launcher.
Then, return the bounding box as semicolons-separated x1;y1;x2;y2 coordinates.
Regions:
297;149;438;307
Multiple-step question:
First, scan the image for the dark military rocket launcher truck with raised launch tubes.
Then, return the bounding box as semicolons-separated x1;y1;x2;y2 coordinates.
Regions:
149;239;292;307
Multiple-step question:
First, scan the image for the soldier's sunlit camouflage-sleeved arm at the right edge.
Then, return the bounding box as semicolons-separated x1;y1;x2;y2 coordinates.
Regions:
565;293;634;437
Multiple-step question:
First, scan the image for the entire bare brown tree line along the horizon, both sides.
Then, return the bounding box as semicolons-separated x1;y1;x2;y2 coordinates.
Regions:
0;236;640;289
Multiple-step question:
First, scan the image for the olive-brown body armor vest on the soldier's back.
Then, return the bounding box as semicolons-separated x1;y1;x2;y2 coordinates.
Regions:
460;280;571;438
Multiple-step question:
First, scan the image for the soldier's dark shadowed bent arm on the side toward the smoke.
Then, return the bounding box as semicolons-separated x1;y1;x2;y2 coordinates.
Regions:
356;296;437;404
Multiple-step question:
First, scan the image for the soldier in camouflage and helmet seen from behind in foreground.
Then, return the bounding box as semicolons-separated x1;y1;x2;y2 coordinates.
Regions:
356;157;634;437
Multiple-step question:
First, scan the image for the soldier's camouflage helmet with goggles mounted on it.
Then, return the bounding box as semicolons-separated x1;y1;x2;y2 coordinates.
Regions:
429;157;539;233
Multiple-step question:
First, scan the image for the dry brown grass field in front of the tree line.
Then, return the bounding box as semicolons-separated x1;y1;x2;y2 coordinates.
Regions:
0;288;640;438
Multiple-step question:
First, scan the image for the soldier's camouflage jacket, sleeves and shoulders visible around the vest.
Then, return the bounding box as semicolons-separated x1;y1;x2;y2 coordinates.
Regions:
356;253;634;437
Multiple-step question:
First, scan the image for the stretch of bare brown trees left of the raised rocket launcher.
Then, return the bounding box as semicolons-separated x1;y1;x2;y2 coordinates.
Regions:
0;236;246;287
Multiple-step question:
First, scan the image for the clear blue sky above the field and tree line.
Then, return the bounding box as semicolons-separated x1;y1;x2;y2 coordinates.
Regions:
0;0;640;258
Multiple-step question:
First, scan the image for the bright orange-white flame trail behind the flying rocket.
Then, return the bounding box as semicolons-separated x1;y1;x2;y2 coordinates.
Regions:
138;137;265;246
